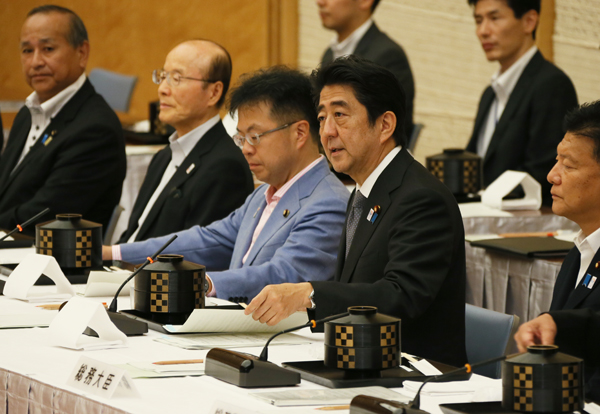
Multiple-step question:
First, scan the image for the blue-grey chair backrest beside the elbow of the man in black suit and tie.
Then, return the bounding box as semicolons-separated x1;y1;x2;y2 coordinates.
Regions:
465;304;519;378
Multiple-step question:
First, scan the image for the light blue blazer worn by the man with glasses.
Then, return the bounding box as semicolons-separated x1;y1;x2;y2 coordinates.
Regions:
121;158;350;303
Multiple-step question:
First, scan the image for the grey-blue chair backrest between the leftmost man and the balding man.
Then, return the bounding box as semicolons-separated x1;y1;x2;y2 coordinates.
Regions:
89;68;137;112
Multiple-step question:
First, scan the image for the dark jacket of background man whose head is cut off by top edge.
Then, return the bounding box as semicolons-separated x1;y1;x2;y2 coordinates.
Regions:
321;23;415;137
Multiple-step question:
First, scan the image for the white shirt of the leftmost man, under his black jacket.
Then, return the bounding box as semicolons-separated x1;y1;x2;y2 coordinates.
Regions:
13;73;86;171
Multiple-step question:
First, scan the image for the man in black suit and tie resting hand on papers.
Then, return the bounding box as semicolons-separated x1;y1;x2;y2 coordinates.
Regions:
246;56;466;366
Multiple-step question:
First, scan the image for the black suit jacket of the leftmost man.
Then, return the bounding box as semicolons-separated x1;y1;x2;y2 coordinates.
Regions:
0;80;126;235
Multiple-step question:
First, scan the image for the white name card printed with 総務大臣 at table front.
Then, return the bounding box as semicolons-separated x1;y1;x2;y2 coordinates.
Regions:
67;356;140;398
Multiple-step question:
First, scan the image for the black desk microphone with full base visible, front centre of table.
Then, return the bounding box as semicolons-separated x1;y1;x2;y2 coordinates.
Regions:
204;312;349;388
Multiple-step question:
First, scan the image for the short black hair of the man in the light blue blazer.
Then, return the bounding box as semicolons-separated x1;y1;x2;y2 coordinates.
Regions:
229;66;319;145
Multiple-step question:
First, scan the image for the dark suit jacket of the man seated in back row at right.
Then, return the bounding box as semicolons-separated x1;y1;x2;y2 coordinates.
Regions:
467;51;577;205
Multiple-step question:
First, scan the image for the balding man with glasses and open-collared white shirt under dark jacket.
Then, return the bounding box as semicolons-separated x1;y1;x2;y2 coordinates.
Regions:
119;40;254;243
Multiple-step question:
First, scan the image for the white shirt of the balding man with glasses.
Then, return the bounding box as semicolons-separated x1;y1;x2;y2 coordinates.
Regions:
127;115;221;243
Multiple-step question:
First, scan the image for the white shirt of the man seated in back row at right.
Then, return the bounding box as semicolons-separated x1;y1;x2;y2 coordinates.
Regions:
477;45;538;158
